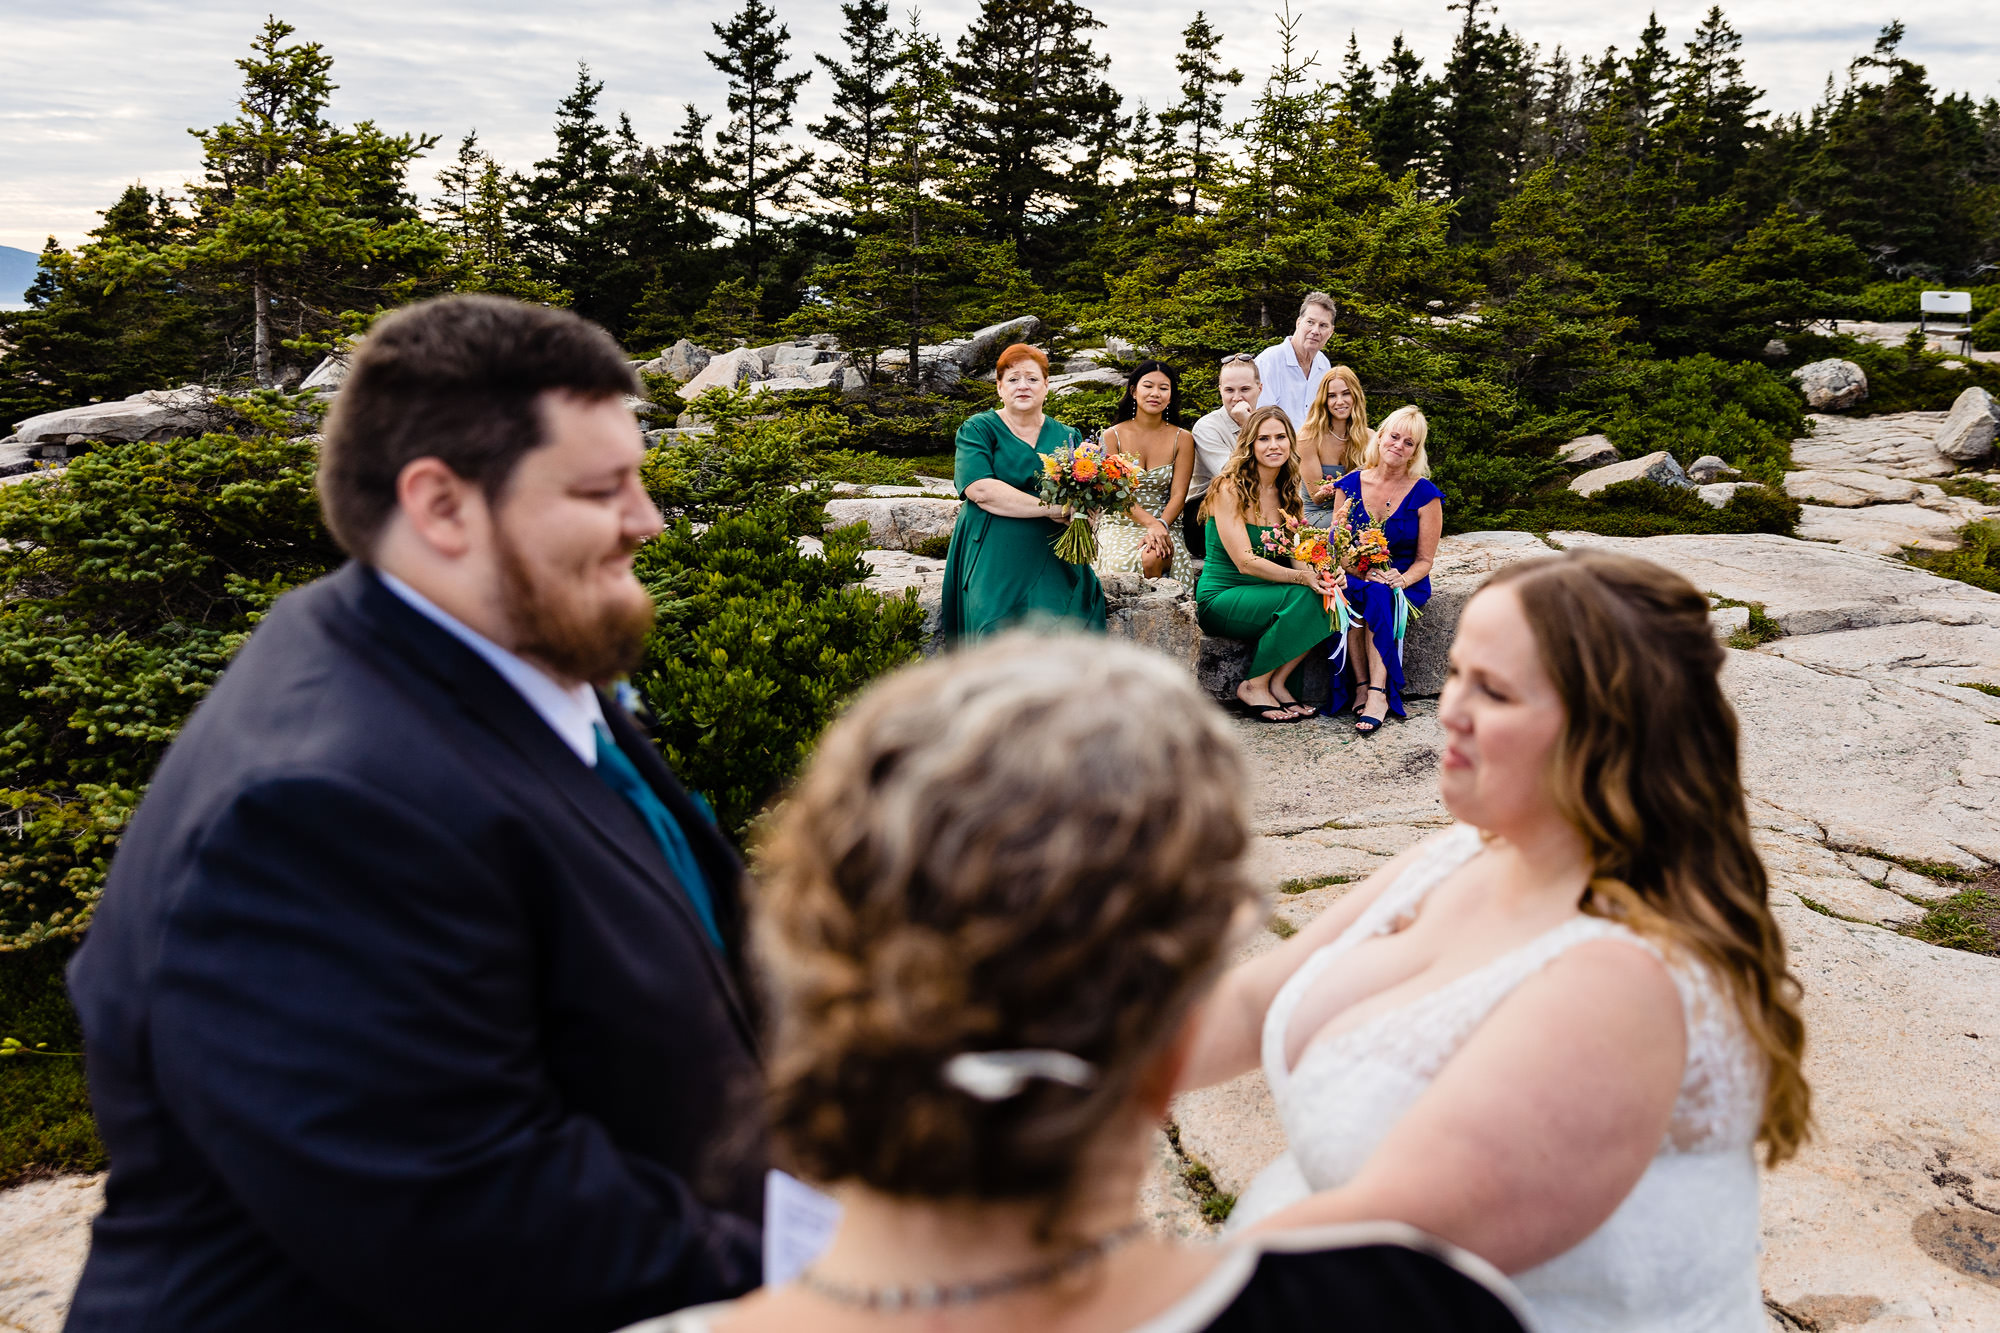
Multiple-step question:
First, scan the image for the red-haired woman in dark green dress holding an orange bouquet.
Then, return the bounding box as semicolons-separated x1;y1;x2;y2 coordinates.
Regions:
940;342;1104;642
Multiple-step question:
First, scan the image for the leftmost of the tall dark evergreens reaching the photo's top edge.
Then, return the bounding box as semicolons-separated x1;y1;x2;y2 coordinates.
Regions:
706;0;812;286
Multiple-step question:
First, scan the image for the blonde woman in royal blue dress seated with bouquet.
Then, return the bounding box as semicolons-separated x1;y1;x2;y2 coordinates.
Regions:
1330;406;1444;737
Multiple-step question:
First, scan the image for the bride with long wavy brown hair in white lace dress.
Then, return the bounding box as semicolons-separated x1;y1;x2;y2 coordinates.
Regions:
1182;552;1810;1333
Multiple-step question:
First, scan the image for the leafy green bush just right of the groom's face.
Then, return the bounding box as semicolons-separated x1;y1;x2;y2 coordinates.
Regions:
632;400;924;839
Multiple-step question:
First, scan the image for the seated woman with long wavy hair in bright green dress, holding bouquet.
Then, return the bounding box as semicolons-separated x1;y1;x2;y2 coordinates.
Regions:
1194;406;1334;723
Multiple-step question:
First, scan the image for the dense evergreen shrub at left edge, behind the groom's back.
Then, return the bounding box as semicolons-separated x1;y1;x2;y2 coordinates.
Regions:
0;404;340;949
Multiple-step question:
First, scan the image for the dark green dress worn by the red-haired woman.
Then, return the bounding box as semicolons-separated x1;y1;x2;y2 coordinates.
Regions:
940;412;1104;642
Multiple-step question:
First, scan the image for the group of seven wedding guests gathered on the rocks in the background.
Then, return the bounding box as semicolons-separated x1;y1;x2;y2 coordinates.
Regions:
944;292;1444;735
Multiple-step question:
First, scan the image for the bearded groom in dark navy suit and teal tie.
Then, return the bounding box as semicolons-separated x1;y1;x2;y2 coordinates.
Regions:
68;296;764;1333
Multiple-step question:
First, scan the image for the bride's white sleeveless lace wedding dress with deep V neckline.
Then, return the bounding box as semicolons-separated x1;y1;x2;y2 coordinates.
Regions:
1230;827;1764;1333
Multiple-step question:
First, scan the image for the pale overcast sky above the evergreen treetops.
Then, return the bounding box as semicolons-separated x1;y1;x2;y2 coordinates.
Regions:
0;0;2000;250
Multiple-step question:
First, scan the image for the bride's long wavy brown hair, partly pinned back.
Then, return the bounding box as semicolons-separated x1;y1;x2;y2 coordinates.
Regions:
1484;550;1812;1165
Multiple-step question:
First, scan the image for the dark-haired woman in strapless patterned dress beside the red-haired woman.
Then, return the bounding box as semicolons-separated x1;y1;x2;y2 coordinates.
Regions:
1096;360;1194;586
